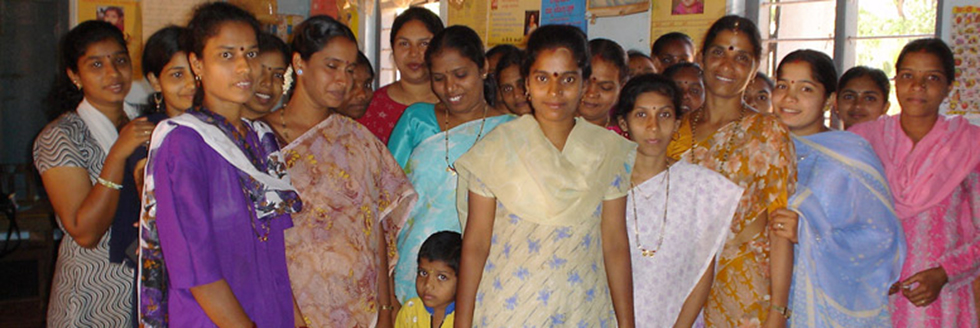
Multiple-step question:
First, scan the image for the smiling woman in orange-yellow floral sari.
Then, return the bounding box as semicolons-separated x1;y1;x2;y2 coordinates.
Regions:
667;16;796;327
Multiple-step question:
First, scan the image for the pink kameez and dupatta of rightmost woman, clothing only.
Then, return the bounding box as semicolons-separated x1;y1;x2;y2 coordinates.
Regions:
850;116;980;328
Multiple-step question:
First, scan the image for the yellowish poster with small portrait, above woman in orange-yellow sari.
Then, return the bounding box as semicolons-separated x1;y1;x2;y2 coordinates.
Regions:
647;0;726;51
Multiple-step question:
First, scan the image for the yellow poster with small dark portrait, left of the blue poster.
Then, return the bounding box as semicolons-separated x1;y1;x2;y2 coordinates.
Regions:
486;0;541;47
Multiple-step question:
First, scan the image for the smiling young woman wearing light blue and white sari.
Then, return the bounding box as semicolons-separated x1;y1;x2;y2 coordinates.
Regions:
770;50;905;327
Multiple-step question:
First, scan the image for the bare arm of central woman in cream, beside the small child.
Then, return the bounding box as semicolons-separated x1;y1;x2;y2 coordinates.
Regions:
454;191;494;328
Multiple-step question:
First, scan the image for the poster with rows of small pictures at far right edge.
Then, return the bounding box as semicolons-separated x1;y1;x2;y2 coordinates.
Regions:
945;6;980;124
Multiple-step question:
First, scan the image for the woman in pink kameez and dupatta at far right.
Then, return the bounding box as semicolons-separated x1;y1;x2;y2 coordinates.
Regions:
850;39;980;327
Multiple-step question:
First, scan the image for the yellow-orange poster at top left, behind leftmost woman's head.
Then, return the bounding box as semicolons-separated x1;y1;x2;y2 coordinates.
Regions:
76;0;143;80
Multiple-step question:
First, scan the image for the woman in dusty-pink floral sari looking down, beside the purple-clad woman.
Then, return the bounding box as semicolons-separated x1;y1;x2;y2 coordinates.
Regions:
263;16;415;327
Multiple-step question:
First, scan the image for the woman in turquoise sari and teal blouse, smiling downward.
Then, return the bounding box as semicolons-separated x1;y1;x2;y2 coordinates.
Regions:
388;26;513;303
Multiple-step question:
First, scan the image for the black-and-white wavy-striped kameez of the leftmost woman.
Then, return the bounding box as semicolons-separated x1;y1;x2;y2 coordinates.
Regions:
34;111;133;327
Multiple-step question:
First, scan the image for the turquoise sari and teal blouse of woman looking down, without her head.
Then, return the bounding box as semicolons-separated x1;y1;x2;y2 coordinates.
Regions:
388;103;514;303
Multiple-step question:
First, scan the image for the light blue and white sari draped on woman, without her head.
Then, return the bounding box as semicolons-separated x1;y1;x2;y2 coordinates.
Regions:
789;132;905;327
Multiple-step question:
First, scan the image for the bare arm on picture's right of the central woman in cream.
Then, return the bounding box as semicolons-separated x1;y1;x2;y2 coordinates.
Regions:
596;196;635;328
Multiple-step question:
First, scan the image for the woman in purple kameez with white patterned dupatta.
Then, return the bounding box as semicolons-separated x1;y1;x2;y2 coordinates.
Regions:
140;3;302;327
